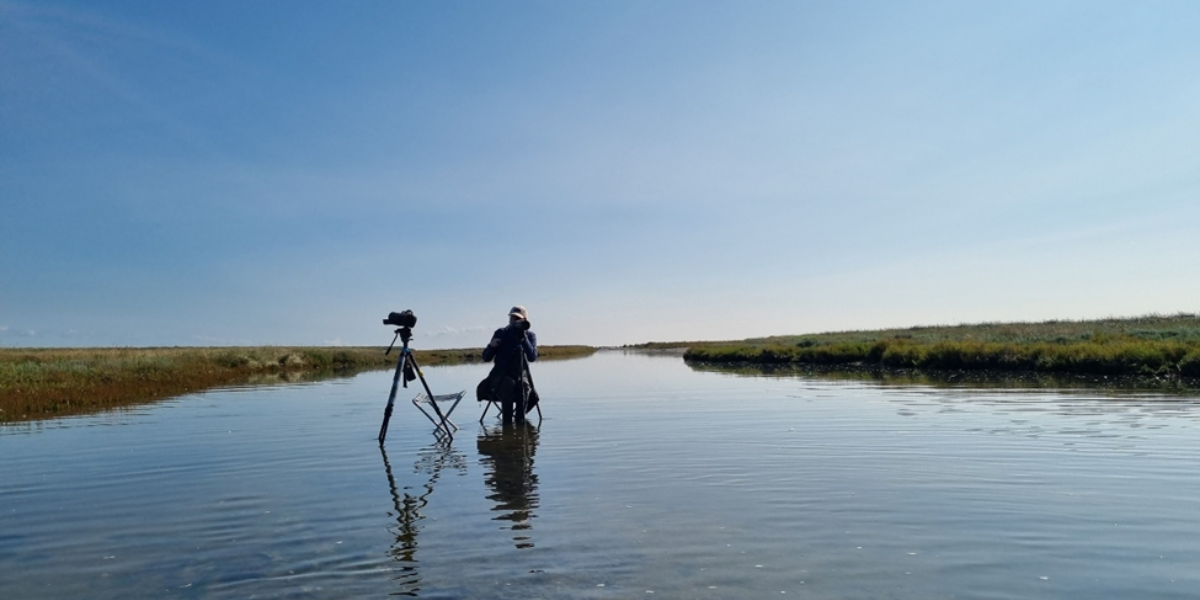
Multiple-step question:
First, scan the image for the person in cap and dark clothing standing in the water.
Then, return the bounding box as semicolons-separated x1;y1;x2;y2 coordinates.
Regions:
484;306;538;422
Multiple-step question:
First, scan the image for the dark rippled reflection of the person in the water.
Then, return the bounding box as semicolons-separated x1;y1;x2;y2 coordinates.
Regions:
479;422;538;548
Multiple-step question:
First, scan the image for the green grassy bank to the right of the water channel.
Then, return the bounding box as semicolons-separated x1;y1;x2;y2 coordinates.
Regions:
684;314;1200;377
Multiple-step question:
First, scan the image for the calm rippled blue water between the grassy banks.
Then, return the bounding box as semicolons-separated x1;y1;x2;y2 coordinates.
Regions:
0;353;1200;599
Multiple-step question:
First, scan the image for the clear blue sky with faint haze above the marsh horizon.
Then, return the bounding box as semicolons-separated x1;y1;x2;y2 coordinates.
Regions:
0;0;1200;349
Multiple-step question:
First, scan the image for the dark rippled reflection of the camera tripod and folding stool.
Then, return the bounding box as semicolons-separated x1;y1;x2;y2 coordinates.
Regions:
379;443;467;596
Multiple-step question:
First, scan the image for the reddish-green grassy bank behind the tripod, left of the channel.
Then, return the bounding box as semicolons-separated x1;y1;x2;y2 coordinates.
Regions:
0;346;594;422
